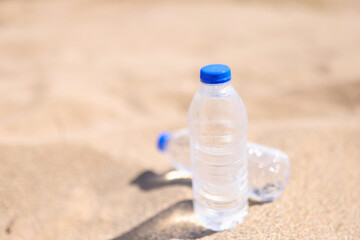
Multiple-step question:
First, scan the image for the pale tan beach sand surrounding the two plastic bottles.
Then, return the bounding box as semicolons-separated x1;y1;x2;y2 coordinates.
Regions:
0;0;360;240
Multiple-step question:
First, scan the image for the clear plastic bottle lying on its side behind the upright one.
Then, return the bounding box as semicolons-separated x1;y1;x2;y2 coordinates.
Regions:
157;128;290;202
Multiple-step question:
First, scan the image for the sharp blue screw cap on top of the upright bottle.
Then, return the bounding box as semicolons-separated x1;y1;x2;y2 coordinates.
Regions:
200;64;231;84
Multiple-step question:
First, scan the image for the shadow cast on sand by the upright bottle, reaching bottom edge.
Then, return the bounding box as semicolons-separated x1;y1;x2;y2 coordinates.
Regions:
112;200;215;240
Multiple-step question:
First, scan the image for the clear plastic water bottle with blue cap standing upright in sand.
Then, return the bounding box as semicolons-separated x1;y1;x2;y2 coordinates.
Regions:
188;64;248;231
